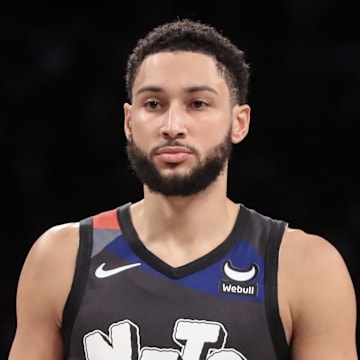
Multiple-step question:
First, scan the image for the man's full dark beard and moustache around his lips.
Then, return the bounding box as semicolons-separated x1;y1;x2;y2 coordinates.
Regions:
126;130;232;197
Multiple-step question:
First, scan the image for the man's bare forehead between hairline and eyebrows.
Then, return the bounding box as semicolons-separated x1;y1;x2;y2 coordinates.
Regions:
132;51;228;94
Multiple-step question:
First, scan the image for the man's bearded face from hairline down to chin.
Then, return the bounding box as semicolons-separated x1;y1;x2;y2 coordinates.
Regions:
124;52;245;196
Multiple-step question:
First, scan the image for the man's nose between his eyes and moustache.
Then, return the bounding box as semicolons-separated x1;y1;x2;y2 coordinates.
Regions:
160;104;186;140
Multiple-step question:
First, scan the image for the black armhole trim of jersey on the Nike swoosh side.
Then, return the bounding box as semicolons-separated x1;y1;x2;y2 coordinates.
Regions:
61;217;93;359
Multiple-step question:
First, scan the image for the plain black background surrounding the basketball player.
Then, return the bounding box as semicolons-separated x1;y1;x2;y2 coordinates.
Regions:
0;0;360;359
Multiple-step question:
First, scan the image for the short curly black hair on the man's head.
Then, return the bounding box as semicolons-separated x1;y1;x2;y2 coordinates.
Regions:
125;19;250;104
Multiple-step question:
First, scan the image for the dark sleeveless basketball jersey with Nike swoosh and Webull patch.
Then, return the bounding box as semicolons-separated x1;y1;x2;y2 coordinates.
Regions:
62;204;290;360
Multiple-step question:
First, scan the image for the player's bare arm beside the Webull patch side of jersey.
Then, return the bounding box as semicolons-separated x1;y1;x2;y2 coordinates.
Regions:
280;230;358;360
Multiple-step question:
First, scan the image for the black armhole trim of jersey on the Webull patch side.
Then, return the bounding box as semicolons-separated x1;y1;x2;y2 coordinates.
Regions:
265;220;290;360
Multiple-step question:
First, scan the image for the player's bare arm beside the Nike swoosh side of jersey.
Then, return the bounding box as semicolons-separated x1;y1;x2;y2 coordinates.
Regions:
9;224;78;360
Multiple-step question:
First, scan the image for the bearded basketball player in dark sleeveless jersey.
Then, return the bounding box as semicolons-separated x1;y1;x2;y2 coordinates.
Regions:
9;19;357;360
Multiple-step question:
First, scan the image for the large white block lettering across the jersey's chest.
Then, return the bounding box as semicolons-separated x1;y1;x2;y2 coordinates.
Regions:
83;319;246;360
